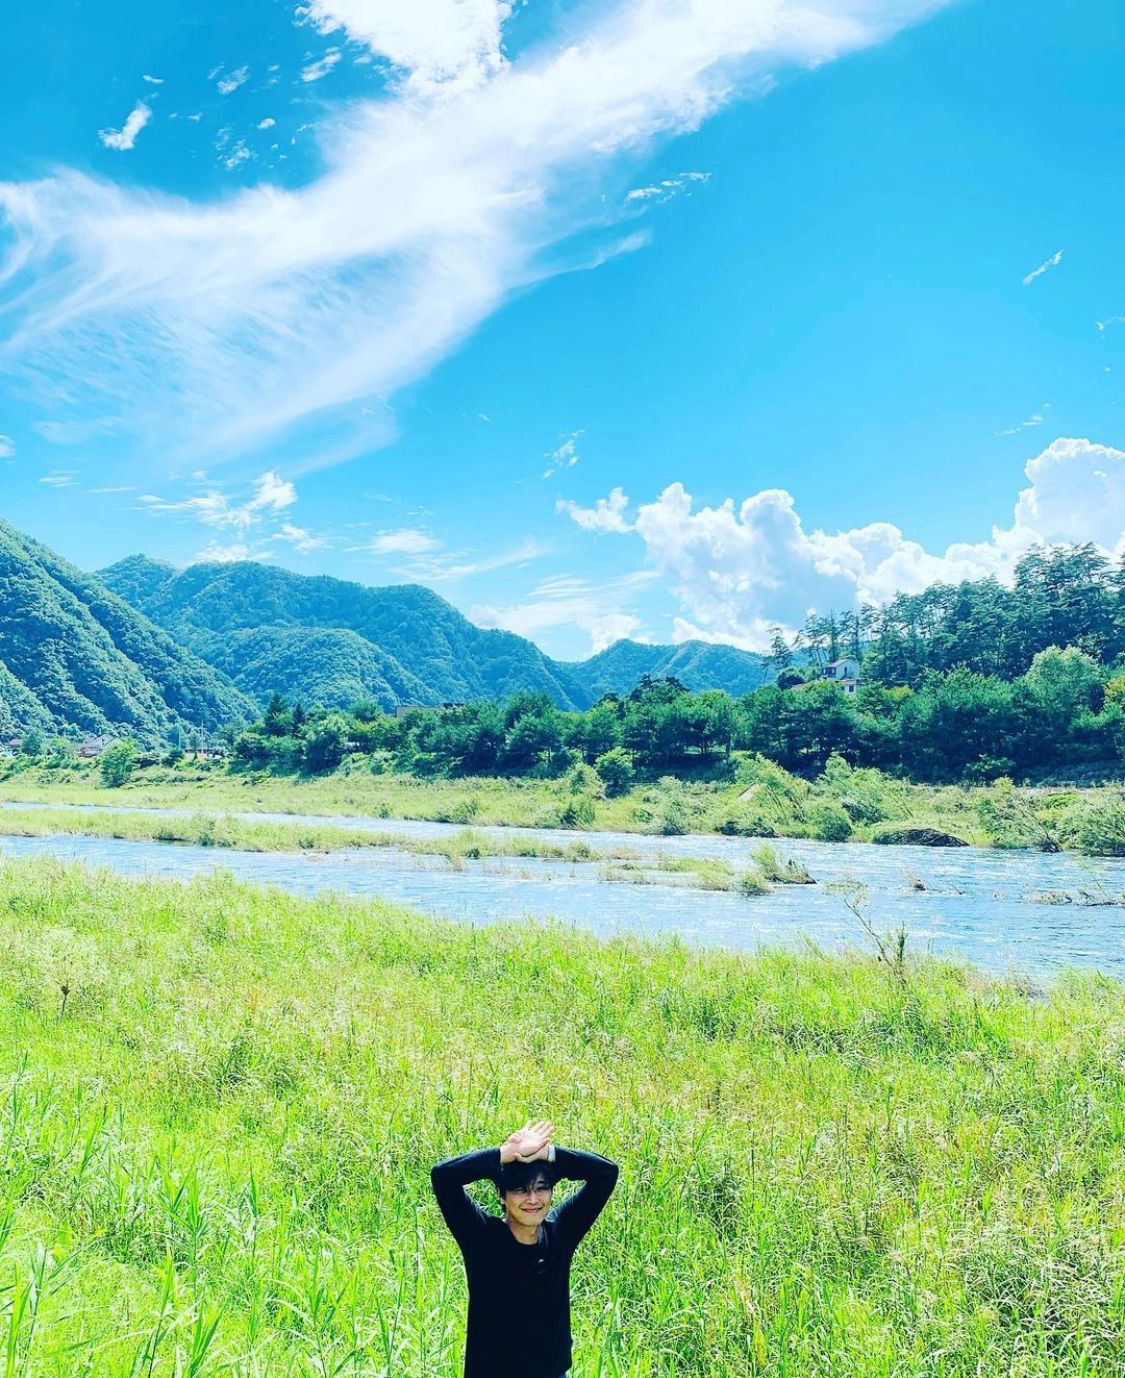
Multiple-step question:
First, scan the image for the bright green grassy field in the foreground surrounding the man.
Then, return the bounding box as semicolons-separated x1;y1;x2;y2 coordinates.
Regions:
0;861;1125;1378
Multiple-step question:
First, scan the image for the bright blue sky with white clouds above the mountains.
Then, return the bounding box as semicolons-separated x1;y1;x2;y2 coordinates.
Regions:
0;0;1125;657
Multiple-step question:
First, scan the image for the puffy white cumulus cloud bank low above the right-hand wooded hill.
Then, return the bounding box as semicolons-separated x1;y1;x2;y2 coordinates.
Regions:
560;438;1125;650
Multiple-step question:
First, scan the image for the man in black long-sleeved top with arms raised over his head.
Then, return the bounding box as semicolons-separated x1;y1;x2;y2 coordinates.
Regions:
430;1120;618;1378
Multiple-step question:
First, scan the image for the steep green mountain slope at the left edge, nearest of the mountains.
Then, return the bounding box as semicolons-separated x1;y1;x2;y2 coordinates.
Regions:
0;521;254;745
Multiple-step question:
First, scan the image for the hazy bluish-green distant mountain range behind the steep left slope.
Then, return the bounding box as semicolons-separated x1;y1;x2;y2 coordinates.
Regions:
98;555;768;708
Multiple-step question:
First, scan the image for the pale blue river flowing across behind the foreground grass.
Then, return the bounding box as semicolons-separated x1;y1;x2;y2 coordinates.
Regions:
0;803;1125;977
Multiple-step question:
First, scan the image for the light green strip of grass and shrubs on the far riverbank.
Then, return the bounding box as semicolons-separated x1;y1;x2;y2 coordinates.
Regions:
15;752;1125;856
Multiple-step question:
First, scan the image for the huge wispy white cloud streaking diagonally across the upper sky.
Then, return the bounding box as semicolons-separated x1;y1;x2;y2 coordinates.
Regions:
0;0;946;460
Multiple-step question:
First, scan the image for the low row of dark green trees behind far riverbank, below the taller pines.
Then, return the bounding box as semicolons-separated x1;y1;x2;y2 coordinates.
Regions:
224;646;1125;791
